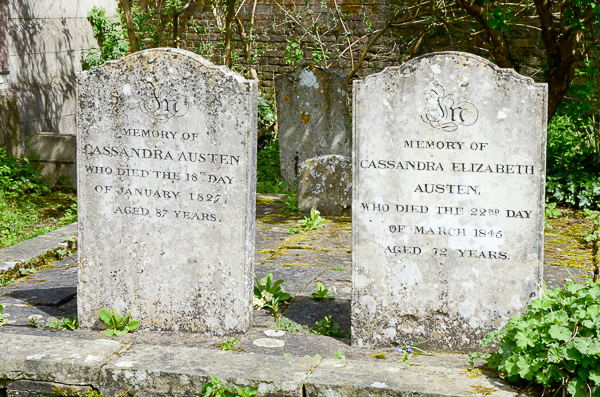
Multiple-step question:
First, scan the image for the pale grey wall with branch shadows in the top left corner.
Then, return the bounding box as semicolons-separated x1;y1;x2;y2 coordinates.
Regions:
0;0;117;155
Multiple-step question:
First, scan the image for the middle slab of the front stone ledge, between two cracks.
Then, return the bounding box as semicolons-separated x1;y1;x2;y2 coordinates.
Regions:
99;346;319;397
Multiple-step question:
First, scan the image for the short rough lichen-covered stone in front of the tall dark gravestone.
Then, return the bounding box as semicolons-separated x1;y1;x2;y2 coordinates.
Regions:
297;154;352;216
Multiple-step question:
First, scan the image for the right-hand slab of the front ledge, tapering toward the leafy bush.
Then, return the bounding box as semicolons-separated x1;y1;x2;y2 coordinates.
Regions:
305;359;522;397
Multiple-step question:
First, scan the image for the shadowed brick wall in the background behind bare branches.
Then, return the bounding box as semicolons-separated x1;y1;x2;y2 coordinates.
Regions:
172;0;544;92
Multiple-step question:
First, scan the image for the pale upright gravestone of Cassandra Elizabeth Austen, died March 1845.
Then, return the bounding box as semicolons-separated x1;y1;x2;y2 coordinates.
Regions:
352;52;547;352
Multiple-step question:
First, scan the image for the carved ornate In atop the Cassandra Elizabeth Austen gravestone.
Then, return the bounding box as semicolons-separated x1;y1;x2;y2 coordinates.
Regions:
421;84;479;132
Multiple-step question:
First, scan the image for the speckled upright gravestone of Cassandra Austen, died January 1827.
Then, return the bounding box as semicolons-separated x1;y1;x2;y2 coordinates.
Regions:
77;49;257;336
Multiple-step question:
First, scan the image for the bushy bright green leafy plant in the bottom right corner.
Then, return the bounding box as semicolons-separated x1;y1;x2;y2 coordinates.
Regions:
469;280;600;397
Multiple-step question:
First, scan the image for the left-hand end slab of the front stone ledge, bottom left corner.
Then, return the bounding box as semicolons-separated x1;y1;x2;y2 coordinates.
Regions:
0;332;123;385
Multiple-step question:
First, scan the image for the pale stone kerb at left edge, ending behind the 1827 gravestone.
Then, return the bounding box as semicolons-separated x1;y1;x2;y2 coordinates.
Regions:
0;222;77;271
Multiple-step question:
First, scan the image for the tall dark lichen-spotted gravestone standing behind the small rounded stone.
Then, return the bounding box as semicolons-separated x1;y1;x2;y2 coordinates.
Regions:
275;67;351;182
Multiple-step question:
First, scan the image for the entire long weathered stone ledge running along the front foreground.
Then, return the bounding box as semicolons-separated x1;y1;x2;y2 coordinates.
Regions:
0;331;520;397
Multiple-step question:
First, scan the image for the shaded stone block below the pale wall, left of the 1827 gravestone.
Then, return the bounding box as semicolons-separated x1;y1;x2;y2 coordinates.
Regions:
27;132;77;189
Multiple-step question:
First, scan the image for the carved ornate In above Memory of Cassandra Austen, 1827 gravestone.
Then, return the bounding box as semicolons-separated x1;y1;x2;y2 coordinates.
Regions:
140;82;189;123
